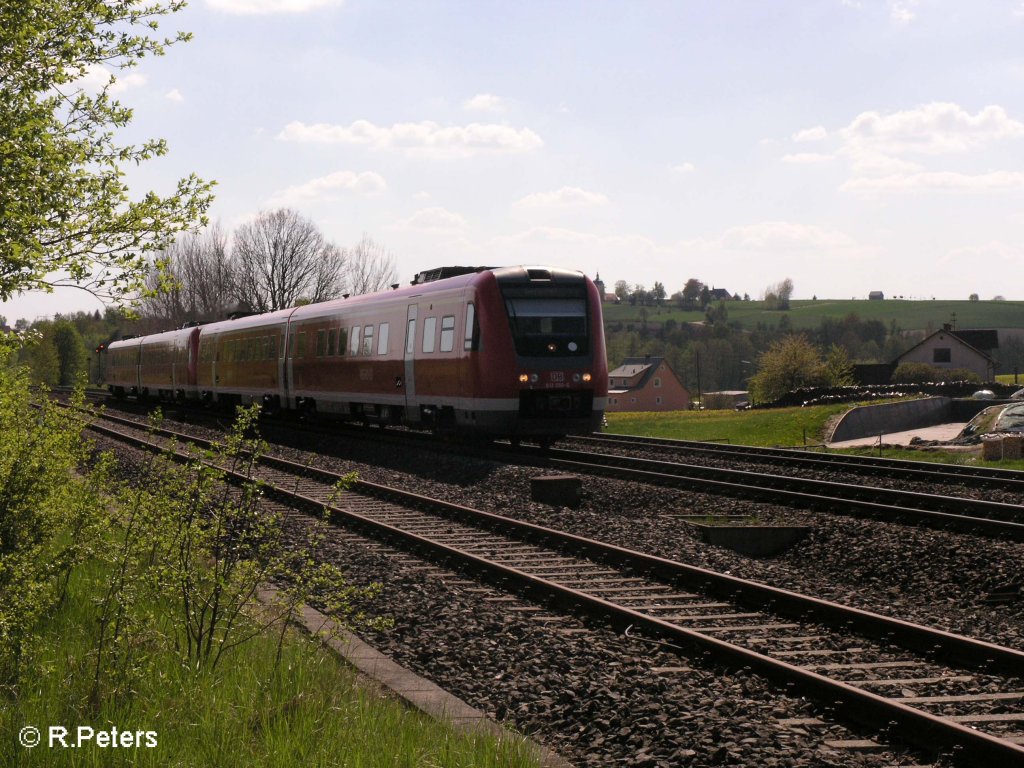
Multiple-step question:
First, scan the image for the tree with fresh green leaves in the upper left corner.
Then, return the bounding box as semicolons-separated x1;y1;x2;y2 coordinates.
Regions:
0;0;211;307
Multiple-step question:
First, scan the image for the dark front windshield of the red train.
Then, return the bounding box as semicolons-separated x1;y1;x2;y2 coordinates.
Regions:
505;296;590;357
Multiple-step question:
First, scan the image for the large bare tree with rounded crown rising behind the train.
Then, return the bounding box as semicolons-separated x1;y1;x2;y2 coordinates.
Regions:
231;208;345;312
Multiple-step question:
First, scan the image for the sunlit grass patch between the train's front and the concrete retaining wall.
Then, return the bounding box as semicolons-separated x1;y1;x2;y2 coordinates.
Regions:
605;404;851;446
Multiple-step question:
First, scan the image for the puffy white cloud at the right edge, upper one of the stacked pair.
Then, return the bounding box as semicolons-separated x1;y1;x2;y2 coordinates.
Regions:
840;101;1024;155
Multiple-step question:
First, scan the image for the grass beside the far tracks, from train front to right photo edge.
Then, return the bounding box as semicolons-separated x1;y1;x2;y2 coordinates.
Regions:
605;403;1024;470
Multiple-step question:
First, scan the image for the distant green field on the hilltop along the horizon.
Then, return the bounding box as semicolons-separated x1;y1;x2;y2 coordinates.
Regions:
603;299;1024;331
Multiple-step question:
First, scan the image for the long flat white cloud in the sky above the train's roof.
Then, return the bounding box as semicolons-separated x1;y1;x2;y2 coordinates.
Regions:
278;120;544;157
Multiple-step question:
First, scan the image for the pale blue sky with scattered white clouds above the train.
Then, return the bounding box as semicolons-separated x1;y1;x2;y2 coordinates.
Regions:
6;0;1024;321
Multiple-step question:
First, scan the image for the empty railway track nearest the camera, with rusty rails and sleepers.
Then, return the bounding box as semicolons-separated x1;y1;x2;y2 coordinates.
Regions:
77;405;1024;766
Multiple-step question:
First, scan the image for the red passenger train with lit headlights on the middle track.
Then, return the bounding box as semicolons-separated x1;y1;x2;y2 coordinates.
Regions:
104;266;608;440
